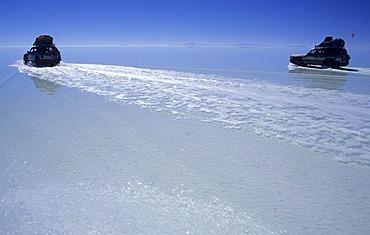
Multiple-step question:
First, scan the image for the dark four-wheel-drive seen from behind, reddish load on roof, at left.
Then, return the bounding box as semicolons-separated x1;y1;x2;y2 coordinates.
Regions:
23;35;62;67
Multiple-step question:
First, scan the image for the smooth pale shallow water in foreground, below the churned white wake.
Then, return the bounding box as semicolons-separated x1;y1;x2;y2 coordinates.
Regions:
0;74;370;234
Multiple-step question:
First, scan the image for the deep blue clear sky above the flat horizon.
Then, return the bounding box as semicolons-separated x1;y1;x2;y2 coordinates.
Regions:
0;0;370;47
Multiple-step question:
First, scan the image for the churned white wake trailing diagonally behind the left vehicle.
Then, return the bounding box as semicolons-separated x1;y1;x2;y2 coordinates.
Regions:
15;62;370;166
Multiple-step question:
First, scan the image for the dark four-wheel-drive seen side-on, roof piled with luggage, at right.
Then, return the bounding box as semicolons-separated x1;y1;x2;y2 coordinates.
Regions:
289;37;351;68
